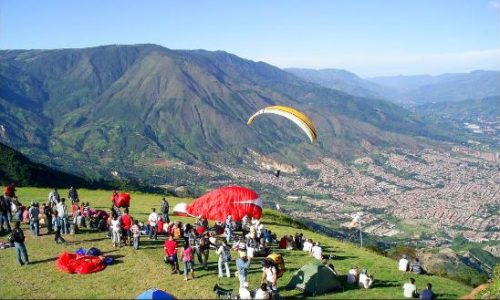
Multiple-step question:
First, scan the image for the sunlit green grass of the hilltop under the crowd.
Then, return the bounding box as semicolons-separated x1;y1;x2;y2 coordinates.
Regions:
0;188;472;299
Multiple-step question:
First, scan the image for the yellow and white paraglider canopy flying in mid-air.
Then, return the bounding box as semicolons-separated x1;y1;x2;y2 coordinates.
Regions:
247;105;317;143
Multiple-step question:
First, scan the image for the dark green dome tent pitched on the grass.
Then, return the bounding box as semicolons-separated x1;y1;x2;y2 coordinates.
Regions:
287;262;342;296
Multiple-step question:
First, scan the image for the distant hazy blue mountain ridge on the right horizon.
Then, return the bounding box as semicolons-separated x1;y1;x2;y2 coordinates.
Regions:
285;69;500;106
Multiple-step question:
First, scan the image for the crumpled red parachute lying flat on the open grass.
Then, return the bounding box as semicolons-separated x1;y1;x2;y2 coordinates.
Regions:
56;252;106;274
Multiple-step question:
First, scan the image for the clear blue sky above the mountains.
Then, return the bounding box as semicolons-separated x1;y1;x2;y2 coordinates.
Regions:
0;0;500;76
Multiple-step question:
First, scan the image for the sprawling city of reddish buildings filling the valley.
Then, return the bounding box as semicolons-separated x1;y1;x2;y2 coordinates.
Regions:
176;149;500;246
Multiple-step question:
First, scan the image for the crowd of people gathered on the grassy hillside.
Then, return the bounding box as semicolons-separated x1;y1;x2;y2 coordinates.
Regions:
0;185;435;299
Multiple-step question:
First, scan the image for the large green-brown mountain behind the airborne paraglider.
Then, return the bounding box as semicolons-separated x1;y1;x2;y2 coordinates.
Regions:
0;44;446;182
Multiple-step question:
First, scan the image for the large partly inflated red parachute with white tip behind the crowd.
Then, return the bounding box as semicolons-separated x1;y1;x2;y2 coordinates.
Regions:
174;186;262;222
